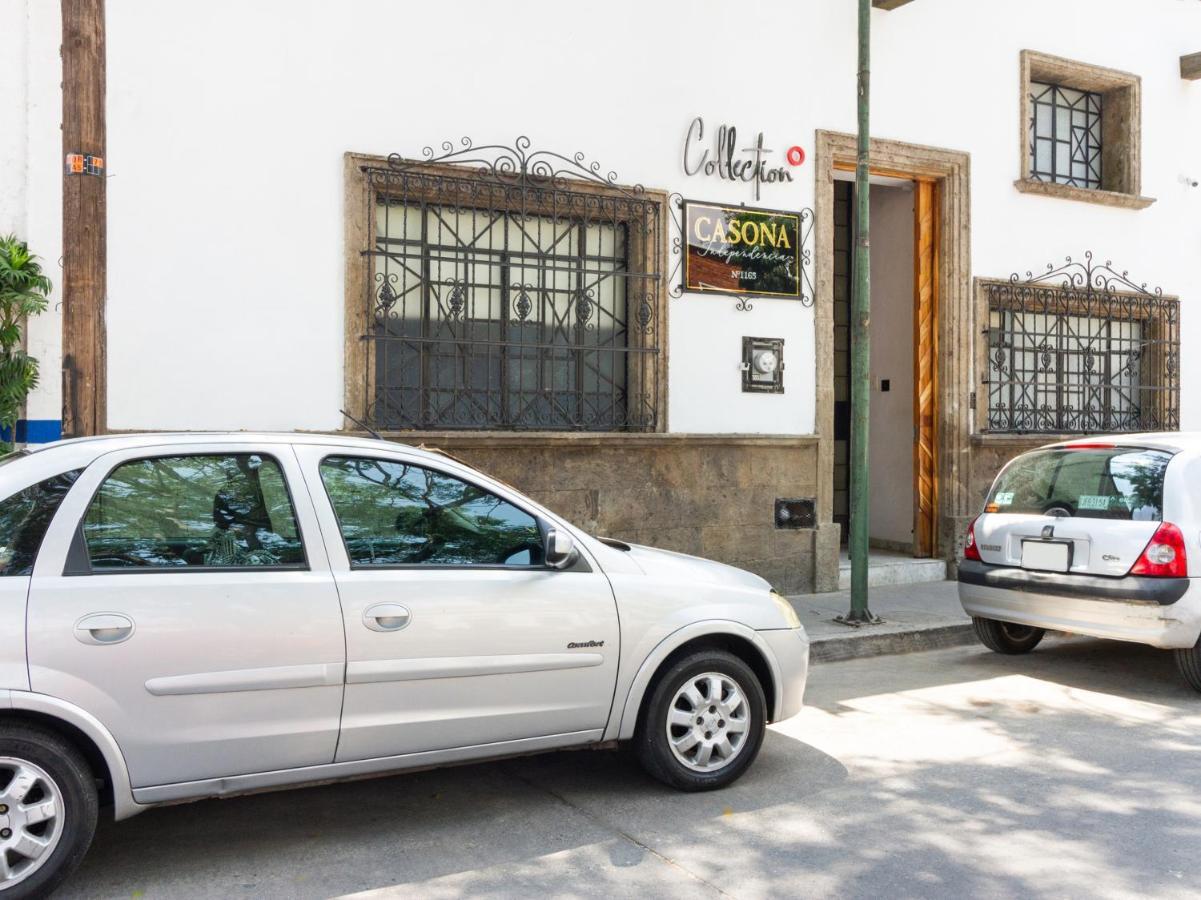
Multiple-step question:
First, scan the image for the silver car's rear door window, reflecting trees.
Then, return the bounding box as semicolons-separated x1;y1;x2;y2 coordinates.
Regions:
83;453;305;572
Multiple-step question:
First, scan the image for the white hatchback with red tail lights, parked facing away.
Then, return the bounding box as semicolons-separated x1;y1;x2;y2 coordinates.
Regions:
958;434;1201;691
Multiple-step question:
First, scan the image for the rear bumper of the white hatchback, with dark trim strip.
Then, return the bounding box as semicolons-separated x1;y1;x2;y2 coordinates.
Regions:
958;560;1201;649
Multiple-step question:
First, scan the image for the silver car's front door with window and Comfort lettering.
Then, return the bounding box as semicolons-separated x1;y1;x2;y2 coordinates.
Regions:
297;445;620;762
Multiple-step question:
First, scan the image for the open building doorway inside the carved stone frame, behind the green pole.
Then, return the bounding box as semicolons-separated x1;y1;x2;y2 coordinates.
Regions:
832;168;938;558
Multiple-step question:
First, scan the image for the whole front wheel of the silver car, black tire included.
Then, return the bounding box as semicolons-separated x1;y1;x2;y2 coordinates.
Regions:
634;649;767;791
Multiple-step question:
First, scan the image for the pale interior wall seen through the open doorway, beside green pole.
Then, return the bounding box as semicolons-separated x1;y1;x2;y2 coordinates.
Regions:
868;186;914;544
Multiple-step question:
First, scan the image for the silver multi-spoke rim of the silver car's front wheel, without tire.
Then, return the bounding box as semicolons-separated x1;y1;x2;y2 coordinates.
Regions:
667;672;751;771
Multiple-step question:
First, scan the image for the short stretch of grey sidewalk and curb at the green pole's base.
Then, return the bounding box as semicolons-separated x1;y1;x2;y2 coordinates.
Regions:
788;582;975;662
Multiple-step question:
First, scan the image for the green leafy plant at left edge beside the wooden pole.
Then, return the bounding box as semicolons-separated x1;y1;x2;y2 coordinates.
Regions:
0;234;50;449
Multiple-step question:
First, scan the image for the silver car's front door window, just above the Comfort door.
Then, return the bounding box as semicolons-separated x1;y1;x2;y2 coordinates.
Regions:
321;457;543;567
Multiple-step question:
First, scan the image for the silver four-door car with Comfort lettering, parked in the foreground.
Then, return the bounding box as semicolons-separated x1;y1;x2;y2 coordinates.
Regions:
0;434;808;896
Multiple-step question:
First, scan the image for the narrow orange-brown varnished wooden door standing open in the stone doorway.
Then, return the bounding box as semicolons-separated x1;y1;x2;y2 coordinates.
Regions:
913;180;938;556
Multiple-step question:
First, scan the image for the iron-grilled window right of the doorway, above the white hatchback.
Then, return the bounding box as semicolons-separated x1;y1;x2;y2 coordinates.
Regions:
981;252;1181;434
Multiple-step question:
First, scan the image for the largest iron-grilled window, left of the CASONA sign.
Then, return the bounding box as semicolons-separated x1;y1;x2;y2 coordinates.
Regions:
363;166;661;431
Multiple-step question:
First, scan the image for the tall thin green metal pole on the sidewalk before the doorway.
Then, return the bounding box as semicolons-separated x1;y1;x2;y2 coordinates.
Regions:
847;0;874;624
